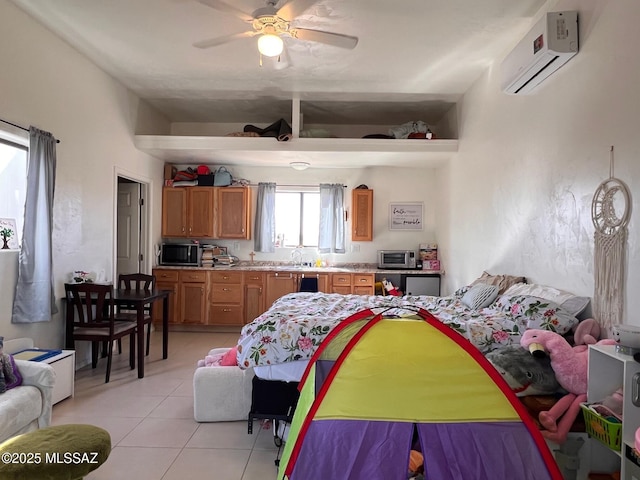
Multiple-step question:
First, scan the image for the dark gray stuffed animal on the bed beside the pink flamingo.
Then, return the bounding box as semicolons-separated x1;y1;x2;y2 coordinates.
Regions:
486;345;560;397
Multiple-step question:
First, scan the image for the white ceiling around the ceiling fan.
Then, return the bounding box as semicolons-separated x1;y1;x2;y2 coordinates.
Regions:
12;0;545;167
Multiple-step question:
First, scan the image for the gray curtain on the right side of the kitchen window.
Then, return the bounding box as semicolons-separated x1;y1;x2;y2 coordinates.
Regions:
318;183;345;253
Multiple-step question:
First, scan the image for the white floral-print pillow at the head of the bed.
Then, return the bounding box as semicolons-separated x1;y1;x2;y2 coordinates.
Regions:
495;294;578;335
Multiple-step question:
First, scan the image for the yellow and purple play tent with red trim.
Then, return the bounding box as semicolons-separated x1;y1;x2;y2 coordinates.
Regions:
278;310;562;480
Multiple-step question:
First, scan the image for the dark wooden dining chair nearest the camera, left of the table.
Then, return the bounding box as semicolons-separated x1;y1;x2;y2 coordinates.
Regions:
64;283;137;383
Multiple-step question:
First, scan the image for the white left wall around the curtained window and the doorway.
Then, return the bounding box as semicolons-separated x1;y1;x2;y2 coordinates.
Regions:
0;1;169;347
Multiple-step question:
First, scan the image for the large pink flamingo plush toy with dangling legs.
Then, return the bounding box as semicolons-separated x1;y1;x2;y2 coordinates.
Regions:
520;329;615;443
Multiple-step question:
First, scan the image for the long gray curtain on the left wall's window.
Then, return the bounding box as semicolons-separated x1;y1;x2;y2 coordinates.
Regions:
11;127;58;323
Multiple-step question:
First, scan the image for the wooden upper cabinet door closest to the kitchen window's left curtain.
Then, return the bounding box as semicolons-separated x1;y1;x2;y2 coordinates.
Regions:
216;187;251;240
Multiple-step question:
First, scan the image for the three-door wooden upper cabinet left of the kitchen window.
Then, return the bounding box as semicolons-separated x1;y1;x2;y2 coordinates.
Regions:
162;187;251;239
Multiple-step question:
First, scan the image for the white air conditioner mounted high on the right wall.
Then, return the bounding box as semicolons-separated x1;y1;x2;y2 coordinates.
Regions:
500;11;578;95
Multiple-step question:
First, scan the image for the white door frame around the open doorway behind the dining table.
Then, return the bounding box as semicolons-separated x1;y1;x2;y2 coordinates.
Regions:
111;166;154;285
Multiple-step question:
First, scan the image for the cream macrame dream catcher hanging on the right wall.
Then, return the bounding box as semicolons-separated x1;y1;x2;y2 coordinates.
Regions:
591;147;631;328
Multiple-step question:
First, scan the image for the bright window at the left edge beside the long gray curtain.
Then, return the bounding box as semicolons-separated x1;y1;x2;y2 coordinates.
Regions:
0;132;28;245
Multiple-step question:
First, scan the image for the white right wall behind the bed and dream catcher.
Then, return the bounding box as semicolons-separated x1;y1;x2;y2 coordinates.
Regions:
437;0;640;325
